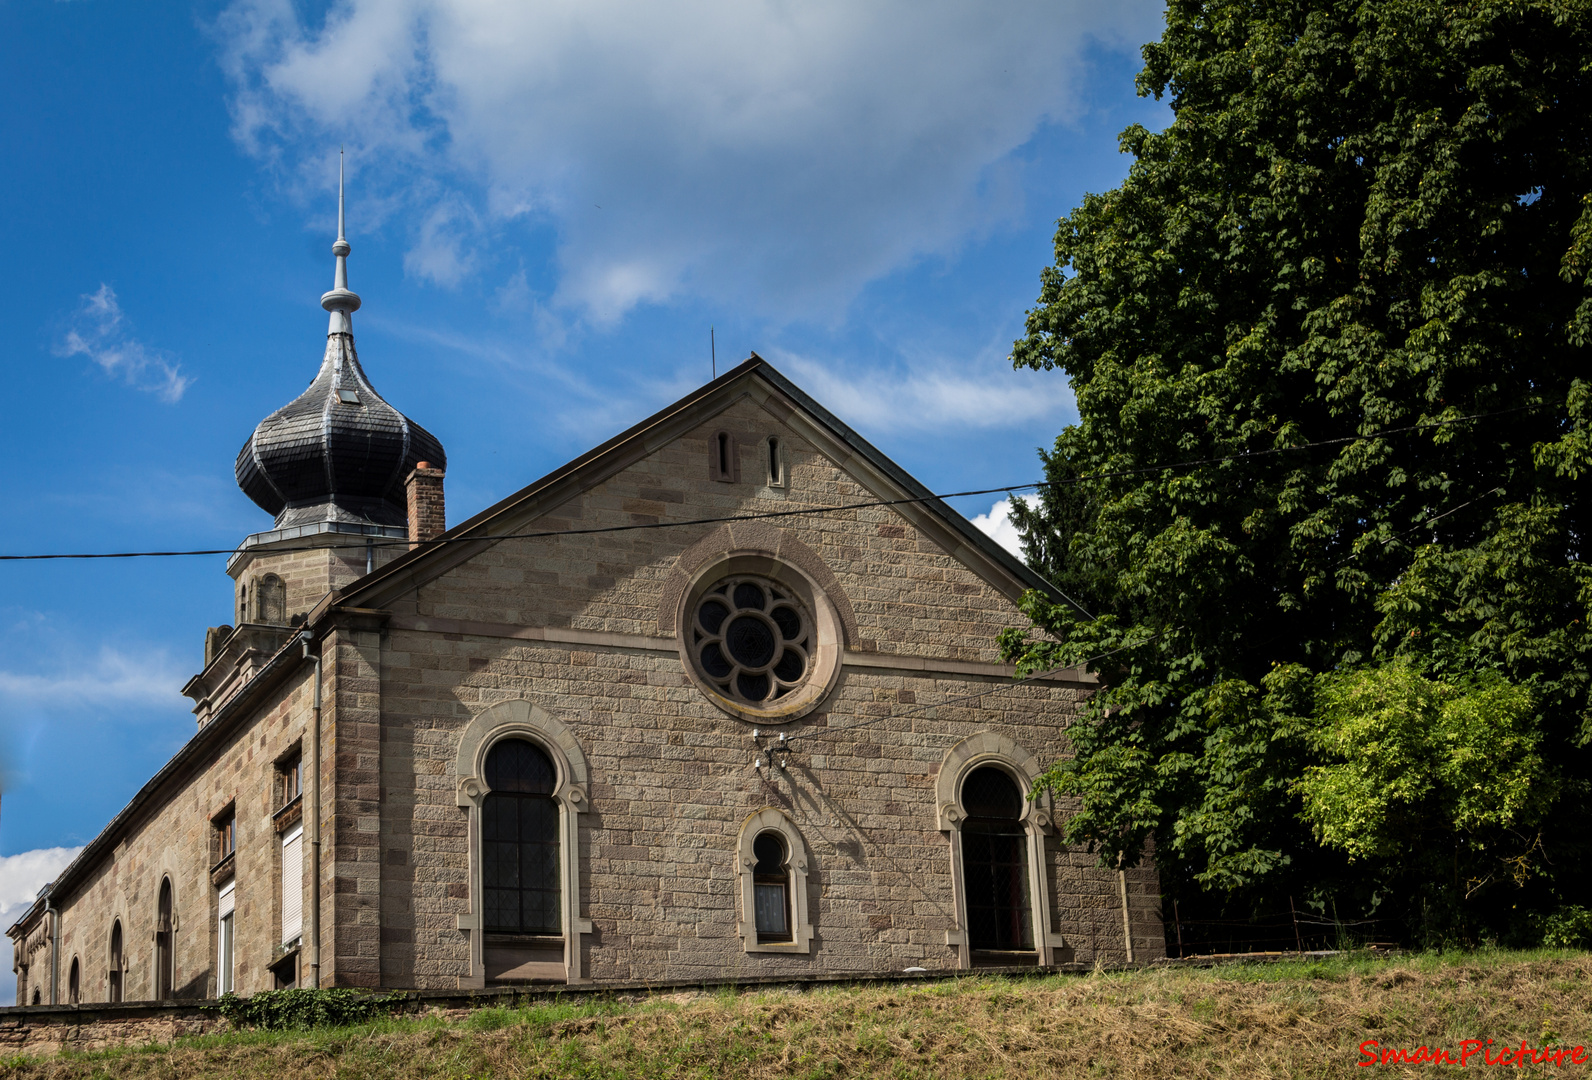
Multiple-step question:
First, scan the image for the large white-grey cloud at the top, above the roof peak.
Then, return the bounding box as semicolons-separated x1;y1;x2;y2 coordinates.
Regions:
215;0;1162;322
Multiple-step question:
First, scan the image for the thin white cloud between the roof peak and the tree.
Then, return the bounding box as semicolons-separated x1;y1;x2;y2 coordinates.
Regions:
769;349;1073;432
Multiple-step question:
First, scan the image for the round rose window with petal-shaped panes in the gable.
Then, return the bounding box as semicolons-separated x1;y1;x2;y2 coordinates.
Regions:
691;577;812;706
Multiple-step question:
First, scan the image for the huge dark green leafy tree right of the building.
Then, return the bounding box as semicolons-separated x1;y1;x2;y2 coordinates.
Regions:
1001;0;1592;936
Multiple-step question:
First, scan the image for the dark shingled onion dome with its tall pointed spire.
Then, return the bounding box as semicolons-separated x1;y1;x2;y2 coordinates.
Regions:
236;155;446;543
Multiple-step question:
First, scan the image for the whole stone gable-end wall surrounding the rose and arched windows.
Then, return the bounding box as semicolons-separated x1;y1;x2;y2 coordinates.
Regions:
361;400;1164;988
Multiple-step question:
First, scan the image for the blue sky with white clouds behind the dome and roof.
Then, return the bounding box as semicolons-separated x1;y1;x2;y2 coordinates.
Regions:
0;0;1167;943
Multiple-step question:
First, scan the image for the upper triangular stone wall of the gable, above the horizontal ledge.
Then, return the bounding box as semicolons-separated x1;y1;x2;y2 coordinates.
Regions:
393;398;1020;661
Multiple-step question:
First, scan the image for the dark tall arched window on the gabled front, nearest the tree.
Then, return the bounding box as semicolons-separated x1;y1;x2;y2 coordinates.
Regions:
962;765;1033;953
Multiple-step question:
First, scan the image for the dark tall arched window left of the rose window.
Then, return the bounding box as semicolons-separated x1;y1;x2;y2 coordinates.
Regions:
481;739;564;933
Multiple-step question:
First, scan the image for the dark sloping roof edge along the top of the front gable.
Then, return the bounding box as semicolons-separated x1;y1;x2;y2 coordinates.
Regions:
321;352;1071;621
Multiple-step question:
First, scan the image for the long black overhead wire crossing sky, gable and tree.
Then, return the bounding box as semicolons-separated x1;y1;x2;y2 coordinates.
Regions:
0;403;1547;562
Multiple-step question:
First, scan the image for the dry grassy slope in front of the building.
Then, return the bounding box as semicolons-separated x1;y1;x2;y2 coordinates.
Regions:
0;953;1592;1080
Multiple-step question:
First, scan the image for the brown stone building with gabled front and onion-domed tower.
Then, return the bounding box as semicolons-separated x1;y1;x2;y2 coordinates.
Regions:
8;192;1164;1005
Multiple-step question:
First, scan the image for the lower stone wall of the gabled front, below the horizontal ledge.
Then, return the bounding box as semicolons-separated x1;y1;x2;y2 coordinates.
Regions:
380;632;1162;988
